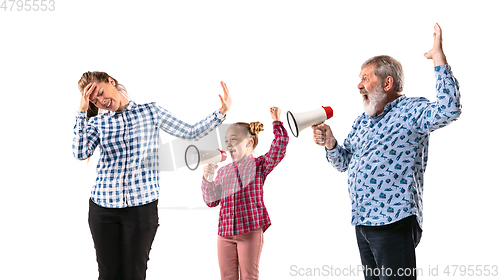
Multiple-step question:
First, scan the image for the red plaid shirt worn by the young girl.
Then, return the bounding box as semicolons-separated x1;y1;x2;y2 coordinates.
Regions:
201;121;289;237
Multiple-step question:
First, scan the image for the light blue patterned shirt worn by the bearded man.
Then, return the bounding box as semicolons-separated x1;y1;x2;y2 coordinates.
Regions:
326;64;461;227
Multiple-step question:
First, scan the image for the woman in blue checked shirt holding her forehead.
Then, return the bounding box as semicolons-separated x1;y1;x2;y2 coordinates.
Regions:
73;72;231;279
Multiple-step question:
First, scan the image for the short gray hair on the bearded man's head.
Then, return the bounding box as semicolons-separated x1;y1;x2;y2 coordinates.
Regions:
361;55;405;92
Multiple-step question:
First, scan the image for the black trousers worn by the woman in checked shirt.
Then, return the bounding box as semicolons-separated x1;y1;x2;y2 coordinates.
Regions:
89;199;159;280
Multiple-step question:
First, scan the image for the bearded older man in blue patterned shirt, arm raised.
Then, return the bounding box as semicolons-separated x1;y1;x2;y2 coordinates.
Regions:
313;24;461;279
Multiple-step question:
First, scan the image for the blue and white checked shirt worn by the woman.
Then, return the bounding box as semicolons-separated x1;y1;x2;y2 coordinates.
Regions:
73;101;225;208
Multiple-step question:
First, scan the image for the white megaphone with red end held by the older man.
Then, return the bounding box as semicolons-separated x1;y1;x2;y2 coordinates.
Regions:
286;106;333;137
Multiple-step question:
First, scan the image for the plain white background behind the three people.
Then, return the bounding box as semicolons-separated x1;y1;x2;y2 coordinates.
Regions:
0;0;500;279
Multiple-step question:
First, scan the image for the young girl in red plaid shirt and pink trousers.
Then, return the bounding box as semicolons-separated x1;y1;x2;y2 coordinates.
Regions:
201;107;288;280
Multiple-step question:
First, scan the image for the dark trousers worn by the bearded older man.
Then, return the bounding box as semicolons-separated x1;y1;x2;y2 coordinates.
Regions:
356;216;422;280
